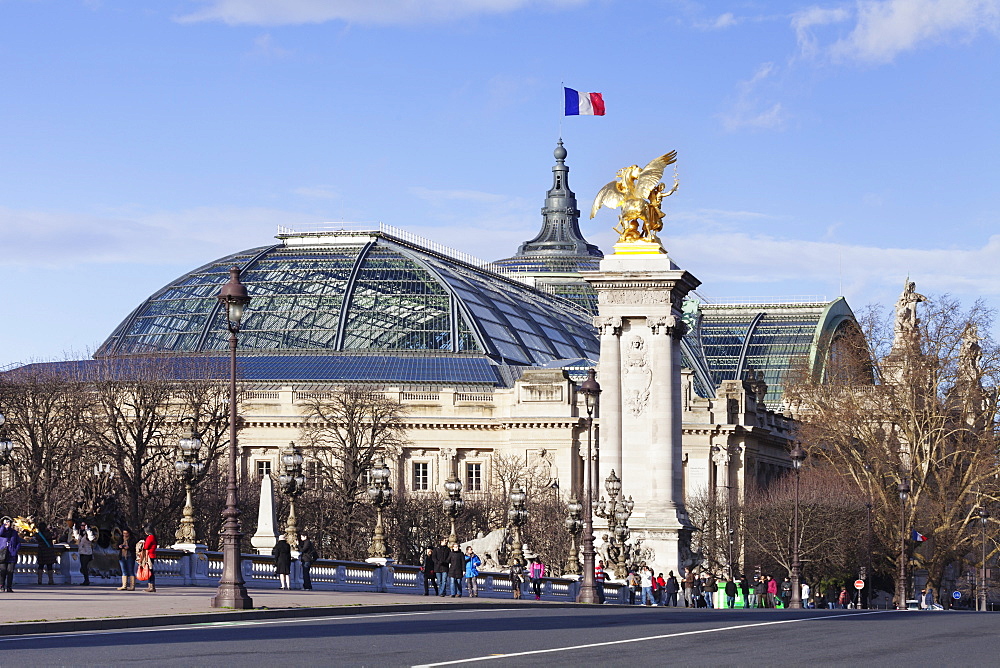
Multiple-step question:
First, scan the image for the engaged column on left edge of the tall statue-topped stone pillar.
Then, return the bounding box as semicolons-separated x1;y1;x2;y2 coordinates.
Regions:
594;316;622;490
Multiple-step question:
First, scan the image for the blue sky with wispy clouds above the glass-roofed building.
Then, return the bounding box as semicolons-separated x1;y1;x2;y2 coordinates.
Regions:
0;0;1000;368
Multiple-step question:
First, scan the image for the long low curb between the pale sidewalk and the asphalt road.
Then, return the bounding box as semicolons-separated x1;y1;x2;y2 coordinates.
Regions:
0;599;580;637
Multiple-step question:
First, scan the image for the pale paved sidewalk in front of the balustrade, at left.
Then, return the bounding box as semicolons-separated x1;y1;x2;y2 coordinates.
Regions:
0;585;576;636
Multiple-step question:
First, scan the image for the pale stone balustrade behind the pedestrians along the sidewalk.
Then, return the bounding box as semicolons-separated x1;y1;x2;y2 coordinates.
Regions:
14;543;628;603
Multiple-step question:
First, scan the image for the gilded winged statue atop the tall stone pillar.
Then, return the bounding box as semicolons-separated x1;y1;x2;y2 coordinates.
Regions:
590;151;679;244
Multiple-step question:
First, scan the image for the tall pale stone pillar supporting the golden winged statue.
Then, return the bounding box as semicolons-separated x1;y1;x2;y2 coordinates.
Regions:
584;253;700;575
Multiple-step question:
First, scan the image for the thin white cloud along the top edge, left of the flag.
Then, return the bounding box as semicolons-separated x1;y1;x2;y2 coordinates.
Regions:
178;0;587;26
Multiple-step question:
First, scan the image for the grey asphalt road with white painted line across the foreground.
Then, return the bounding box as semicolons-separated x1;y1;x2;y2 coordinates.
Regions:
0;605;1000;668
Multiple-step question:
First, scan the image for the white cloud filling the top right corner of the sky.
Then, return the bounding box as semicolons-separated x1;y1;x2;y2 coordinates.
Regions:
792;0;1000;64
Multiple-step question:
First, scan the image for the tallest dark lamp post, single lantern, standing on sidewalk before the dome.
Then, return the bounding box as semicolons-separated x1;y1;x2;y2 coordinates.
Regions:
211;267;253;610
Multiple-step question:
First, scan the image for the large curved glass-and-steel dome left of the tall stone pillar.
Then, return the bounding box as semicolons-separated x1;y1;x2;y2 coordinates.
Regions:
95;228;599;365
